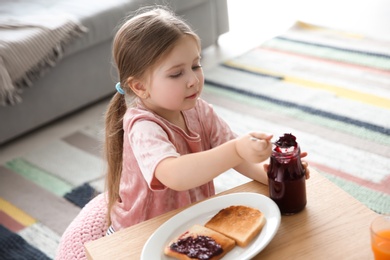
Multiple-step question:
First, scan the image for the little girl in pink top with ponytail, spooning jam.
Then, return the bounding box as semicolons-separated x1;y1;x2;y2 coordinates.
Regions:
105;8;310;234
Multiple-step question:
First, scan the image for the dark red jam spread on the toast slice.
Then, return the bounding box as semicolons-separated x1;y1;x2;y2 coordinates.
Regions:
170;236;223;260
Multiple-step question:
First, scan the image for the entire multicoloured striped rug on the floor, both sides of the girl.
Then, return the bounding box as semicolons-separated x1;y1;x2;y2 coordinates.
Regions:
0;23;390;259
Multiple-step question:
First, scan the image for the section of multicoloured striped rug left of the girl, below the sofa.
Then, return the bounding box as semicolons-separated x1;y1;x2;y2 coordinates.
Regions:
0;125;104;259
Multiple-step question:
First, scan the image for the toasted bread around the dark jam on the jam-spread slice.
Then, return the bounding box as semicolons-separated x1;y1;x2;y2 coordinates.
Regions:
164;225;236;260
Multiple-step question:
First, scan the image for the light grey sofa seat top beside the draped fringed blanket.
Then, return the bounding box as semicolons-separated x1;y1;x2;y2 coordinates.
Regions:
0;0;213;55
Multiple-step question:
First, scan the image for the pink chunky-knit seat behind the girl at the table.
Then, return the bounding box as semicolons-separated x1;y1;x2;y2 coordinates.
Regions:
55;193;108;260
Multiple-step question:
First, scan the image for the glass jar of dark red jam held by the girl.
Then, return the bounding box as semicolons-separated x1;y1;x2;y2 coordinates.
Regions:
267;134;306;215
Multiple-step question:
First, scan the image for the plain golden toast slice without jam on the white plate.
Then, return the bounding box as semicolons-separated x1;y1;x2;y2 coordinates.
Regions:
205;205;266;247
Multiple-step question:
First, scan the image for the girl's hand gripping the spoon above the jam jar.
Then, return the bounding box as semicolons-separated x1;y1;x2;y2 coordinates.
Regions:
236;132;272;163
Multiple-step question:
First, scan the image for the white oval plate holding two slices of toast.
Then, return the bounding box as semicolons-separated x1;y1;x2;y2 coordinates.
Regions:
141;192;280;260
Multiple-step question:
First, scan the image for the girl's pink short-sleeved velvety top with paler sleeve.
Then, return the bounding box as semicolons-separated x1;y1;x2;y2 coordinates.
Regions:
111;99;236;231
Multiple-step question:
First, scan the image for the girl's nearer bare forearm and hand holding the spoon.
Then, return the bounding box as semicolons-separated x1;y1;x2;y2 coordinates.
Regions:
155;133;272;191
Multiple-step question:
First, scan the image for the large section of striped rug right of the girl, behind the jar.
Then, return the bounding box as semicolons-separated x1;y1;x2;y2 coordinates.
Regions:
204;22;390;213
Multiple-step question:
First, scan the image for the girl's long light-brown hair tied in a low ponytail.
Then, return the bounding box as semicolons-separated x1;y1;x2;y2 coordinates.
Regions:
105;7;200;222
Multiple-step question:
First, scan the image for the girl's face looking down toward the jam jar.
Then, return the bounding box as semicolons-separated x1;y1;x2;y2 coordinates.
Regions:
144;36;204;120
